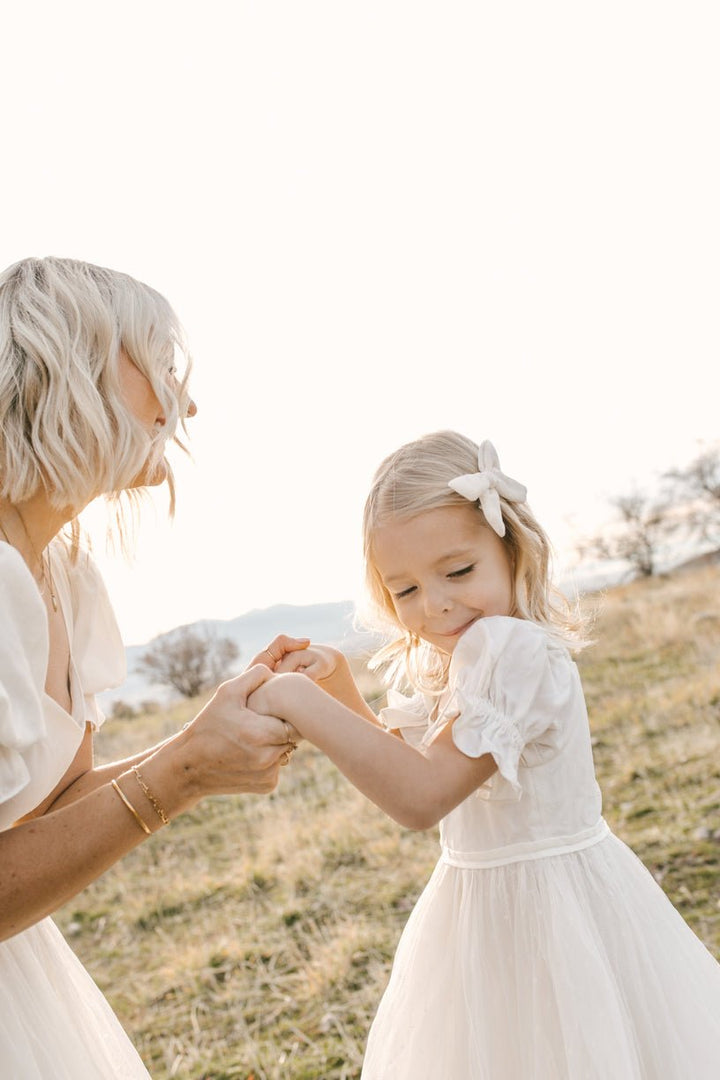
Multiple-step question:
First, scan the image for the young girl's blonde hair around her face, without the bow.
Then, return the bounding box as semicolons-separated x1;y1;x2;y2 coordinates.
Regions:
363;431;586;691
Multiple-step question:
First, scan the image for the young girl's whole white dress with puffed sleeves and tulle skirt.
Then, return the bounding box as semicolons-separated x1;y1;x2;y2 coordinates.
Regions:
363;617;720;1080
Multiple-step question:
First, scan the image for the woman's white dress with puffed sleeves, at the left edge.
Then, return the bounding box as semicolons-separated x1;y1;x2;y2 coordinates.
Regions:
0;542;149;1080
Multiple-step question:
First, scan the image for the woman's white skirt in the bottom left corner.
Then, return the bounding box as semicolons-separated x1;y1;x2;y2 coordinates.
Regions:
0;919;150;1080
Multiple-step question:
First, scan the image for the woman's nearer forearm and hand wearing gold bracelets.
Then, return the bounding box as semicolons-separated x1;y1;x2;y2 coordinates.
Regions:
0;669;289;939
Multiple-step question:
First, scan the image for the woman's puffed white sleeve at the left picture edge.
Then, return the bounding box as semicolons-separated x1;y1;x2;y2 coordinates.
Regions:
0;543;49;804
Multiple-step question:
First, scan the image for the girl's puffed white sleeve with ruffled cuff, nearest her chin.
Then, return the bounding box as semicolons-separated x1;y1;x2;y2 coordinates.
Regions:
446;617;573;798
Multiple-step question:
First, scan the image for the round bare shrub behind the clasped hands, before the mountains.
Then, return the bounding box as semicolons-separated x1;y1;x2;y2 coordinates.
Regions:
136;626;240;698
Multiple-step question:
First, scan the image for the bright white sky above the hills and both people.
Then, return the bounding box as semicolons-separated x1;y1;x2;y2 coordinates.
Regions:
0;0;720;644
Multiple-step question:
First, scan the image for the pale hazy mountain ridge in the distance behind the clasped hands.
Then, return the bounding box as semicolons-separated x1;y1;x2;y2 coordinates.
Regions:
98;600;388;712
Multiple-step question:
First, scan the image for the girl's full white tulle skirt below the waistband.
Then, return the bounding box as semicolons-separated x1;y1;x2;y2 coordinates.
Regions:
363;835;720;1080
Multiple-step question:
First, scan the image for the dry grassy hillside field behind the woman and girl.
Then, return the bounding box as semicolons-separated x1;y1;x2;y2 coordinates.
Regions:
58;567;720;1080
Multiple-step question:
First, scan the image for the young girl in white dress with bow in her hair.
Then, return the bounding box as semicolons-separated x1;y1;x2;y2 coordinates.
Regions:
249;432;720;1080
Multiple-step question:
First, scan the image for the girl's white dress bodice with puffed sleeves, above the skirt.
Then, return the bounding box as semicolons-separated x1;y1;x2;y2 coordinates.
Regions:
381;617;602;865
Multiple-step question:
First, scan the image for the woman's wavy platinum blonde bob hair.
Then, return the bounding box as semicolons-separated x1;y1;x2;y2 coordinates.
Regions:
0;257;189;511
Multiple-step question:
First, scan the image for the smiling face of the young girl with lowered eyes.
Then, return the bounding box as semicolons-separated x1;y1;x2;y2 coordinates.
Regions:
372;503;513;653
